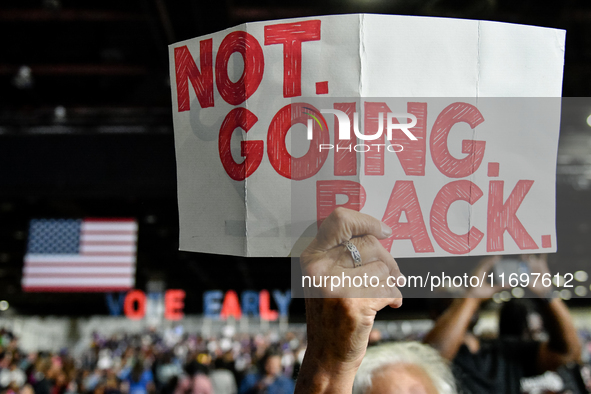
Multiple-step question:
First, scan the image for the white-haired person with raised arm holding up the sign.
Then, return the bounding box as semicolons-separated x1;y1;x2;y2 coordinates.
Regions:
295;208;456;394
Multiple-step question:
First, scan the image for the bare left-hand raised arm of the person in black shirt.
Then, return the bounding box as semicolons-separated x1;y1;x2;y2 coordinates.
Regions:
423;298;481;360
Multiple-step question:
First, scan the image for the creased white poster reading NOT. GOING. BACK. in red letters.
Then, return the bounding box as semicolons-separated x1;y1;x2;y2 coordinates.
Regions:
169;14;565;257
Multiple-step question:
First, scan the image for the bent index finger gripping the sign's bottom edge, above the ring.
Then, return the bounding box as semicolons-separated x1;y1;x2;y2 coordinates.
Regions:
315;207;392;250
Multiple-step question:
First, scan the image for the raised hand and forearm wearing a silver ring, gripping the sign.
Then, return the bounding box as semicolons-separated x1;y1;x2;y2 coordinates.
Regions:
296;208;402;393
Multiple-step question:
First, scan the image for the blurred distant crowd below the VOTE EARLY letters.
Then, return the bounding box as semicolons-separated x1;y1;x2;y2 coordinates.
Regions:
0;326;305;394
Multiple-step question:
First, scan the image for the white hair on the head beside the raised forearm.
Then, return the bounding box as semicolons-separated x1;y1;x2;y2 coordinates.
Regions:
353;342;457;394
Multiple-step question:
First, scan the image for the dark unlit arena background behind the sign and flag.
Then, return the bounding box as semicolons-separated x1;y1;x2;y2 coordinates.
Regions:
0;0;591;315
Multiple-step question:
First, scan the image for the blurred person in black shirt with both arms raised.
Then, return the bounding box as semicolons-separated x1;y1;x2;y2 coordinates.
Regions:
424;256;581;394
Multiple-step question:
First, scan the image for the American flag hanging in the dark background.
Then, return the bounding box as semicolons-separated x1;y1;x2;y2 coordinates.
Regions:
22;219;137;292
